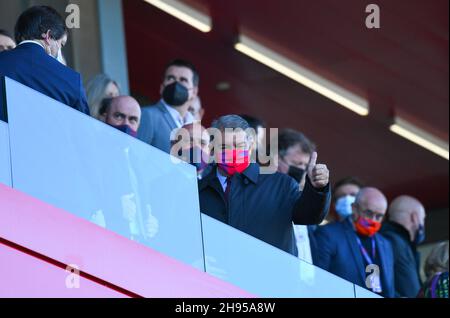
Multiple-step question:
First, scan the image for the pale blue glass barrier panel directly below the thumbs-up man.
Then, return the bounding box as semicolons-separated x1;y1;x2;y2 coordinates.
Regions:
202;214;355;298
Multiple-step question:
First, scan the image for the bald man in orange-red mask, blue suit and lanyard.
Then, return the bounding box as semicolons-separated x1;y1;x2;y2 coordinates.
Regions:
312;187;395;297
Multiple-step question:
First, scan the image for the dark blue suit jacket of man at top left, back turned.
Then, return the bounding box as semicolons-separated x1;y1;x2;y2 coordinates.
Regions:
0;43;89;115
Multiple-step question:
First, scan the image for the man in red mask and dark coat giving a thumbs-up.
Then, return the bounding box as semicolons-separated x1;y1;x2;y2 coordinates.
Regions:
198;115;331;256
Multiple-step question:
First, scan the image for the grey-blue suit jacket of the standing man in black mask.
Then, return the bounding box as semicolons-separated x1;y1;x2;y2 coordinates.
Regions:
138;101;178;153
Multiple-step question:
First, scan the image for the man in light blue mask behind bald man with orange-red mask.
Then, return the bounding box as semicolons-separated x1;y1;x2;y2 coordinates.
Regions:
329;177;364;222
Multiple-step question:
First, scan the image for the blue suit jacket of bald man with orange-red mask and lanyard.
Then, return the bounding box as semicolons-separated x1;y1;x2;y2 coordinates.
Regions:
311;218;395;297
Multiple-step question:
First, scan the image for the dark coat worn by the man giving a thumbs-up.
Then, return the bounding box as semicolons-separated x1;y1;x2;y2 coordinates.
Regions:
199;163;331;256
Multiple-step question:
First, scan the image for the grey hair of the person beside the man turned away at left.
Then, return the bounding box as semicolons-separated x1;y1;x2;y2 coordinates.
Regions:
86;74;120;119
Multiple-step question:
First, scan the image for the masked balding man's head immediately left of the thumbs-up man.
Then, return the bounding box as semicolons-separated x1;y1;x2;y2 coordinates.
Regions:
171;122;210;180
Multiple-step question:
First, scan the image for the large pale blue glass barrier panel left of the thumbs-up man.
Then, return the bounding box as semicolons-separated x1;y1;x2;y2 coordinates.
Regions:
6;78;204;270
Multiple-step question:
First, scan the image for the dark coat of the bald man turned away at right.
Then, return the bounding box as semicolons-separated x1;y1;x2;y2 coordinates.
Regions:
381;222;421;298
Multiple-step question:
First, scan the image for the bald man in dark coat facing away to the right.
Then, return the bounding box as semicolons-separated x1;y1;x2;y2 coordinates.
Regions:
381;195;425;298
